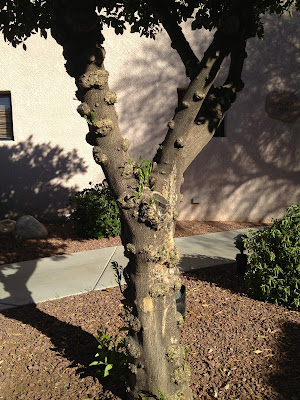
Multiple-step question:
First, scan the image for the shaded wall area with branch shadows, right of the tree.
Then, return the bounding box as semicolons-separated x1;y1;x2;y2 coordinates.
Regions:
182;15;300;221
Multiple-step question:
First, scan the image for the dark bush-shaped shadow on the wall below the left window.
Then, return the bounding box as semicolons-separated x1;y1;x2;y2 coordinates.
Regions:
0;136;87;221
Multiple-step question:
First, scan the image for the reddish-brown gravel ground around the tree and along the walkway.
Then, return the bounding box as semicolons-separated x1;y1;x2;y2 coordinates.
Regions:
0;222;300;400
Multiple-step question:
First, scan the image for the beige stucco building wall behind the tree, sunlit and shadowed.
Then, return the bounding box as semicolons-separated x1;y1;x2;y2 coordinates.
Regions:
0;16;300;220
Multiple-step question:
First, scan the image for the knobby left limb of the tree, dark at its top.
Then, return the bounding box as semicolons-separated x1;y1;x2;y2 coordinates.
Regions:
52;0;135;206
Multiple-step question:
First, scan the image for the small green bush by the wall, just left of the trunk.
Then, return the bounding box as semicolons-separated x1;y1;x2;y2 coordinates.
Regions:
67;181;121;239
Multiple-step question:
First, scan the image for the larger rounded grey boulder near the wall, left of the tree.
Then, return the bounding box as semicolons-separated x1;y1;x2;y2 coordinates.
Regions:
14;215;48;239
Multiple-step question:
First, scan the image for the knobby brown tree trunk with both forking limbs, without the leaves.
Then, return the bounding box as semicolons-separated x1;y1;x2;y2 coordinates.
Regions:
52;0;251;400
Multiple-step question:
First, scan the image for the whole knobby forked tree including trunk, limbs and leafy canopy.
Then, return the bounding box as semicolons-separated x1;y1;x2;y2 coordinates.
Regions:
0;0;300;400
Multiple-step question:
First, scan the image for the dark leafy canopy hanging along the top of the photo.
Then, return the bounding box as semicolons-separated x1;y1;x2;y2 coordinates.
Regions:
0;0;300;49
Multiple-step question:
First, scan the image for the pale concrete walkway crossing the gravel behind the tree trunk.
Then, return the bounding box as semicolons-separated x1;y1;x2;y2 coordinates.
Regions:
0;229;258;311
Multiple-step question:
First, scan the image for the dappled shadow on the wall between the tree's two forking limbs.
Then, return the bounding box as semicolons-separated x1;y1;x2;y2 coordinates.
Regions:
113;32;210;160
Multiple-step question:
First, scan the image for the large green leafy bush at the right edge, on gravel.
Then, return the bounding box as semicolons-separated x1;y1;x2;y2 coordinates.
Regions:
244;203;300;310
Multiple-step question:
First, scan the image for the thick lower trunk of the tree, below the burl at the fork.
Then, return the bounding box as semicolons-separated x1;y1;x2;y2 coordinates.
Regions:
120;216;192;400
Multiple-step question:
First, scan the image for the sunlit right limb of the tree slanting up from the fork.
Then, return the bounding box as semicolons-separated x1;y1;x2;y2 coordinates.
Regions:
154;32;229;200
